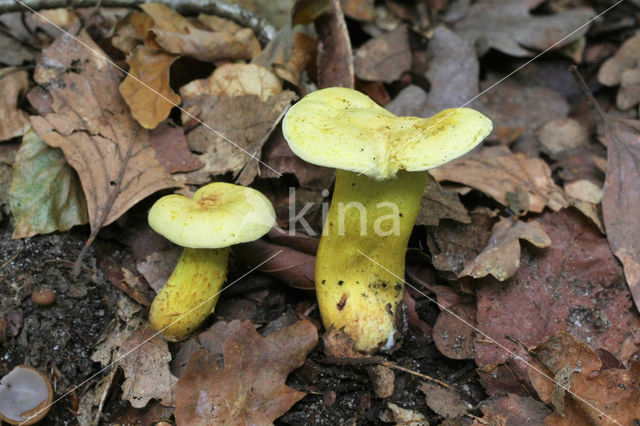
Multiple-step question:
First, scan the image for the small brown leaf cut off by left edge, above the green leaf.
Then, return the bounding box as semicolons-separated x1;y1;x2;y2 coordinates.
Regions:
0;68;30;142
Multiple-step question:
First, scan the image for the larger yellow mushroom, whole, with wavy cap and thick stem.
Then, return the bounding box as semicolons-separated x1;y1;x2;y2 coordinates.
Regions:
282;87;492;353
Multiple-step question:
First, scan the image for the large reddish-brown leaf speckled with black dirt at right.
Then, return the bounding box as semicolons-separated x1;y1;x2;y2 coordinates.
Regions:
475;209;640;388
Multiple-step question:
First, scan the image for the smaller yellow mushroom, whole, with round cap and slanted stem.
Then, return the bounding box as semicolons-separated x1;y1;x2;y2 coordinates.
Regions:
148;182;275;341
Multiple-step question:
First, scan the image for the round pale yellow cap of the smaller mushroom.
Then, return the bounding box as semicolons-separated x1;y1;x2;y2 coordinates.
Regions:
148;182;276;248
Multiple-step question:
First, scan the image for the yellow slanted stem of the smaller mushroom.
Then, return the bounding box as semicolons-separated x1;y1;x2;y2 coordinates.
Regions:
149;247;230;341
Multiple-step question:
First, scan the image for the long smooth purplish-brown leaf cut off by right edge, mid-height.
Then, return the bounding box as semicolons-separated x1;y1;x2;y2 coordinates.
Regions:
602;118;640;309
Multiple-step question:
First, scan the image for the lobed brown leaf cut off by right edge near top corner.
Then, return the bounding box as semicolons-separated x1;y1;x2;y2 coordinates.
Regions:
598;33;640;110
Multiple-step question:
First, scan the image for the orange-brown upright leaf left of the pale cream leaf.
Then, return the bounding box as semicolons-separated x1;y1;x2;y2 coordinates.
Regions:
119;46;180;129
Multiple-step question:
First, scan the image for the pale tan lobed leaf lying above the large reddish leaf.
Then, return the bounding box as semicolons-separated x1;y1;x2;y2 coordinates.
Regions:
458;218;551;281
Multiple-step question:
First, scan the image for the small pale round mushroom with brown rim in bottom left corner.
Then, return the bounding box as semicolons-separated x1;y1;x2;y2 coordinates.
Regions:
0;365;53;425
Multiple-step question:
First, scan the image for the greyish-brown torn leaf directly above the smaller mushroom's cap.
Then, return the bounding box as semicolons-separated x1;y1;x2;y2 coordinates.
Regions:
174;91;297;184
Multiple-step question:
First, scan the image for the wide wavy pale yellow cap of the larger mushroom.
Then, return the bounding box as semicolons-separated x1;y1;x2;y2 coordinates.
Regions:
282;87;492;179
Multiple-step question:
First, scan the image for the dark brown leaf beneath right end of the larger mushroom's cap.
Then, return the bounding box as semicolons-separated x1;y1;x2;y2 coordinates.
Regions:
416;175;471;226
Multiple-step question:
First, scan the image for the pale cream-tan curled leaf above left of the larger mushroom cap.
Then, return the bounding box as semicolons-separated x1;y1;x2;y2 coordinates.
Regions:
180;64;282;104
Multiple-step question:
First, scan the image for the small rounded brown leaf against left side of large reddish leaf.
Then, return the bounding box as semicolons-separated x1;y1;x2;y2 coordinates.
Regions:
433;303;476;359
